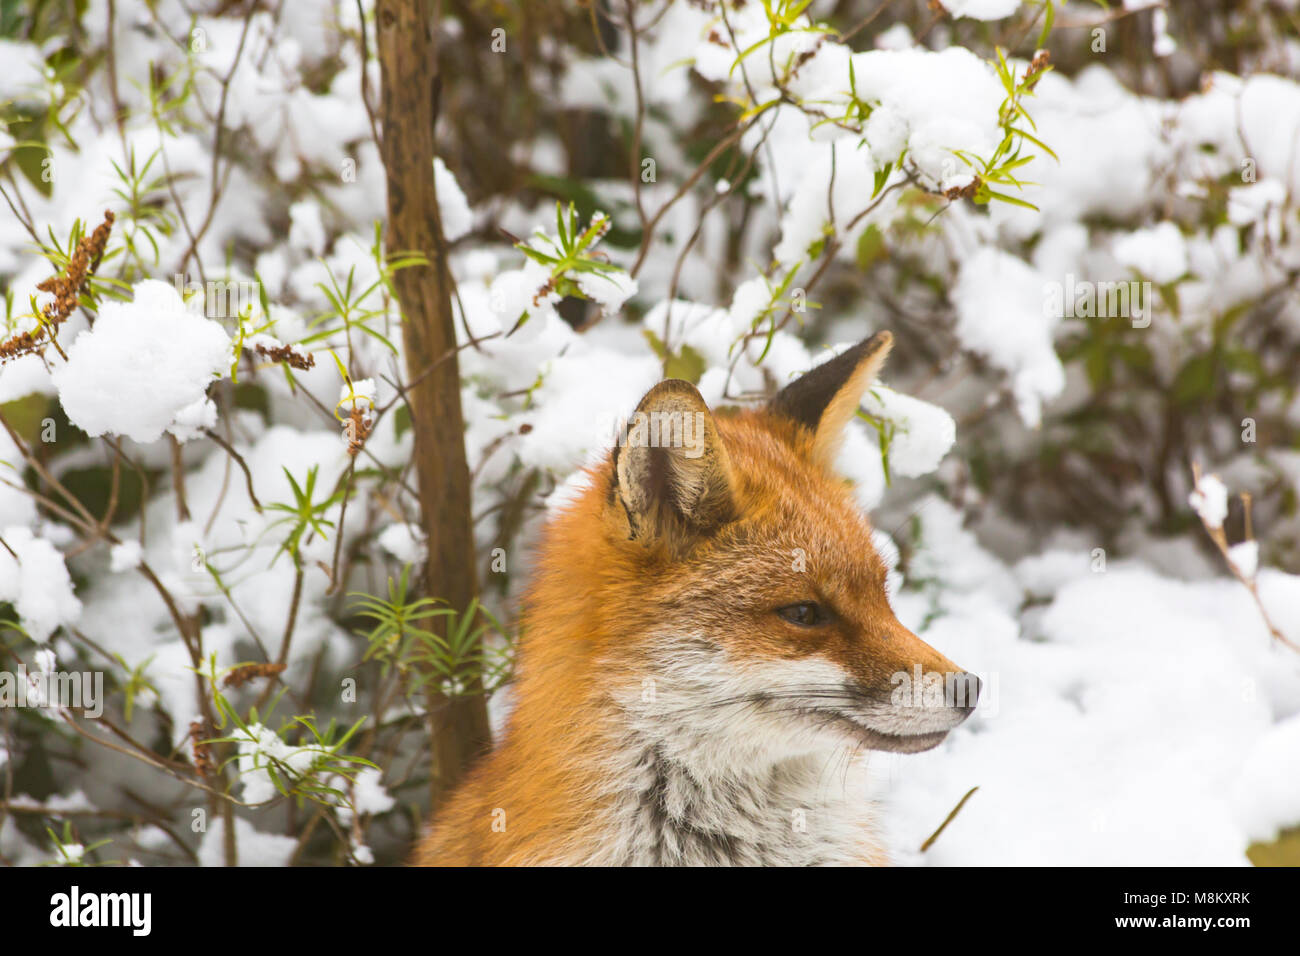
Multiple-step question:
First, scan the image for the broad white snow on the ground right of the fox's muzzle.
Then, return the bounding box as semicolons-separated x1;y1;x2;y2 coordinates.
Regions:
872;522;1300;865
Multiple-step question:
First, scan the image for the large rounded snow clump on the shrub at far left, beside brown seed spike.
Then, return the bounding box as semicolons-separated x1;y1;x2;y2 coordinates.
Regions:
53;280;231;442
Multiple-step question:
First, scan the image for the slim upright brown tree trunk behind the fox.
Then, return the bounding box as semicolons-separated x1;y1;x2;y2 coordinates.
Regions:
376;0;490;809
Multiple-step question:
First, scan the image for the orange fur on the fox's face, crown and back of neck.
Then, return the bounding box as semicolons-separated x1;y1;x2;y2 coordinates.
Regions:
415;339;977;865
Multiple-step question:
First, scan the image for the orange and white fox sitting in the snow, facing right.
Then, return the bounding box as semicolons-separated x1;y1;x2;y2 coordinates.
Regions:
411;330;979;866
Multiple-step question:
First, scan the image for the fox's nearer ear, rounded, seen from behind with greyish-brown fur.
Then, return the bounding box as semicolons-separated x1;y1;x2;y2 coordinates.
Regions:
614;378;736;540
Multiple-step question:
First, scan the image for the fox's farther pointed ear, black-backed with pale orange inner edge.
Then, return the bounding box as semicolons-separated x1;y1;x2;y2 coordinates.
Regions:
767;332;893;466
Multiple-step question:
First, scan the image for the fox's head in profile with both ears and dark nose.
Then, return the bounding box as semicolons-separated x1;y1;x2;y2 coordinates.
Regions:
524;332;979;761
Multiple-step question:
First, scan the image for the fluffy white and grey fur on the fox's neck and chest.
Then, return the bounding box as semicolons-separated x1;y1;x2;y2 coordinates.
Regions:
548;640;879;866
